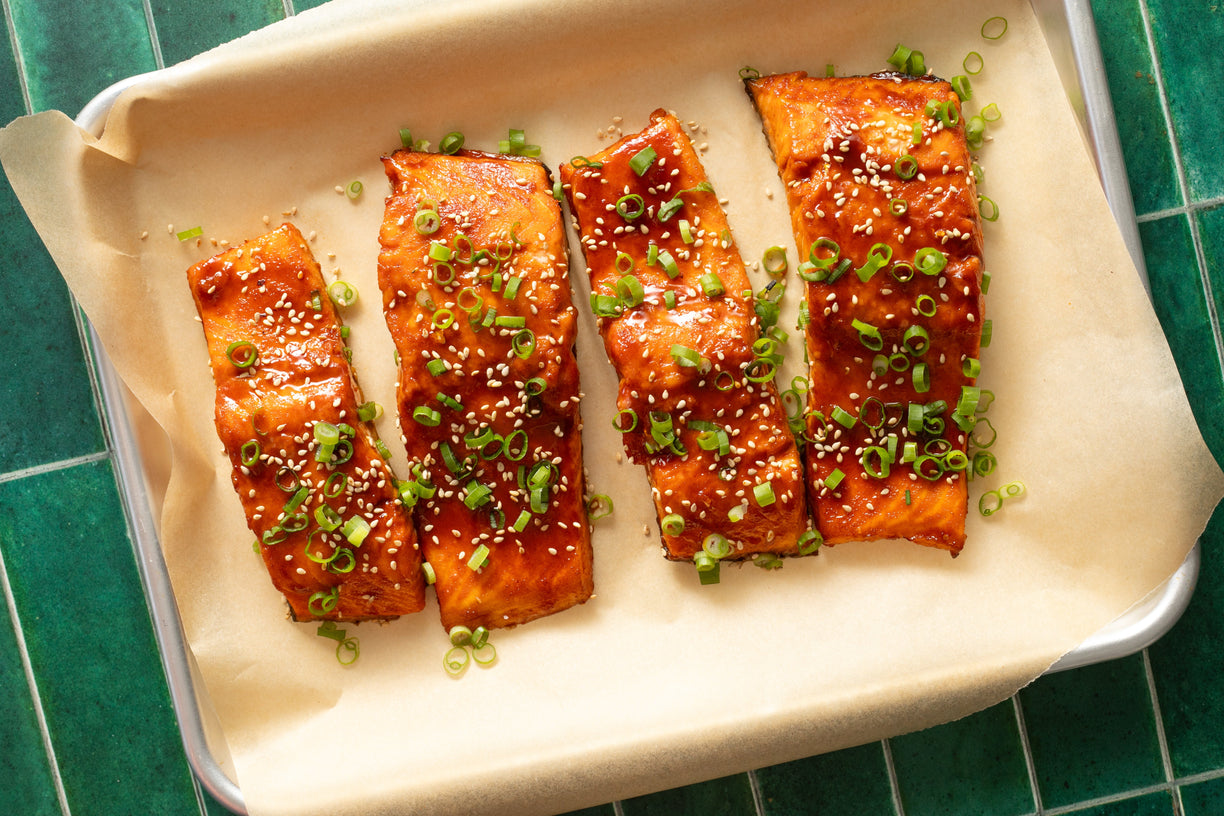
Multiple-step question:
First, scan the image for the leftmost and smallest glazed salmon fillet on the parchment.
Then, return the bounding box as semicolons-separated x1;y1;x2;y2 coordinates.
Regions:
187;224;425;620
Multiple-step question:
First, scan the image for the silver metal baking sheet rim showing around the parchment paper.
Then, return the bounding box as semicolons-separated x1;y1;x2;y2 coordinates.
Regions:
76;0;1200;814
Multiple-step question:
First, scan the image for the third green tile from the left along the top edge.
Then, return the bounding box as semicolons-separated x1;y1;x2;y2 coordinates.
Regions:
152;0;285;65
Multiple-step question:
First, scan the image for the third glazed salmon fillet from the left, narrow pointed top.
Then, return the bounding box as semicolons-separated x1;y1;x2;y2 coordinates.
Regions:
561;110;808;560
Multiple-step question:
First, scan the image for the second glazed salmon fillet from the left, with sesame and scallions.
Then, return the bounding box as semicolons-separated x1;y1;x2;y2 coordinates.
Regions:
378;150;594;629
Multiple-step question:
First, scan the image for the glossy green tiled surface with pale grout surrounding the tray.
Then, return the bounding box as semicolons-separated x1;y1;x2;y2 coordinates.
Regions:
0;0;1224;816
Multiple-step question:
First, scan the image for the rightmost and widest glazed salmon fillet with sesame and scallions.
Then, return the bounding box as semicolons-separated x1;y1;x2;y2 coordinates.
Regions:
745;72;983;555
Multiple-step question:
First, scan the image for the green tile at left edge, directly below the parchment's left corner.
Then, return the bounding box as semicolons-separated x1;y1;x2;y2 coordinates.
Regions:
0;176;104;472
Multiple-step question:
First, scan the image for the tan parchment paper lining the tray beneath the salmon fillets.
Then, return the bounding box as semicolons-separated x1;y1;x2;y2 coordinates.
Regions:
0;0;1224;815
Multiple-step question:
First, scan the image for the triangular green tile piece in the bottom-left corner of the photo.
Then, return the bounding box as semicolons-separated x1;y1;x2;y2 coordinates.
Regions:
0;616;60;816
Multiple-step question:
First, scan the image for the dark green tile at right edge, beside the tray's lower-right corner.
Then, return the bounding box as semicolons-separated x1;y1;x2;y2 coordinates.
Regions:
1148;508;1224;778
